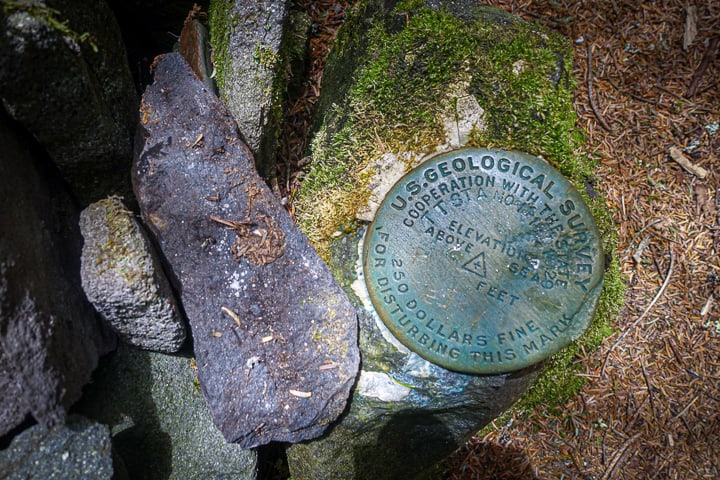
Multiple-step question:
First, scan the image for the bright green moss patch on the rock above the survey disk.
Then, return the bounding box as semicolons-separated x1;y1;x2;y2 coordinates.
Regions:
296;2;609;257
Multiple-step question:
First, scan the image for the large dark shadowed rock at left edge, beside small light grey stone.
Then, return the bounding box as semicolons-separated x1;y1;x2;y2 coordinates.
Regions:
0;111;112;435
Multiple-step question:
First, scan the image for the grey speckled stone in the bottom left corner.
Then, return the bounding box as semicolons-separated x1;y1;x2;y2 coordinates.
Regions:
0;415;115;480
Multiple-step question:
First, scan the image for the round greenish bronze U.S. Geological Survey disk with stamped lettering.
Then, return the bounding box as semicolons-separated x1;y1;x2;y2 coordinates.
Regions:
363;148;604;374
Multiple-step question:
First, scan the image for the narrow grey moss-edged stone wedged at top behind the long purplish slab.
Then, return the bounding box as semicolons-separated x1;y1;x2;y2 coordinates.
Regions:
209;0;309;178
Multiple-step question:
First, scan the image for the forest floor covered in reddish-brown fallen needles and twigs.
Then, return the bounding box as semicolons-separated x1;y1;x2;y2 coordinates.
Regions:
283;0;720;480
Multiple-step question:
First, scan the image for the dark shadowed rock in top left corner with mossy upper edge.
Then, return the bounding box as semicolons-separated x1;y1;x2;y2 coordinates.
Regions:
0;0;137;202
